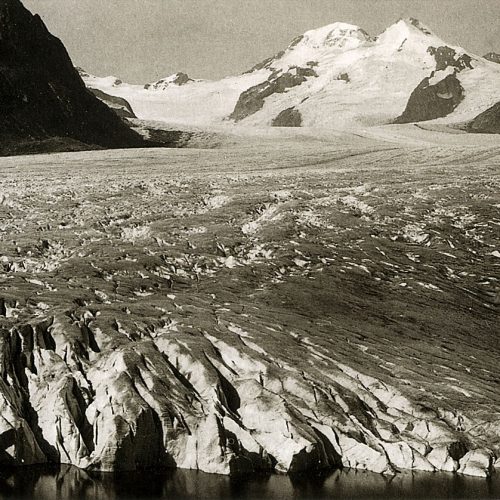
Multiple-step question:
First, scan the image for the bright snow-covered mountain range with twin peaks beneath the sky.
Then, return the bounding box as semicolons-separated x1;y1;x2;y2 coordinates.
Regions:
81;18;500;129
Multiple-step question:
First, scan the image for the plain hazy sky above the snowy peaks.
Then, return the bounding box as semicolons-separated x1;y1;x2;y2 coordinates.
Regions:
23;0;500;83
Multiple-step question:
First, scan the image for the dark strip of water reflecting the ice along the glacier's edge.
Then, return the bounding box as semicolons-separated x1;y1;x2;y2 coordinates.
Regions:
0;465;500;500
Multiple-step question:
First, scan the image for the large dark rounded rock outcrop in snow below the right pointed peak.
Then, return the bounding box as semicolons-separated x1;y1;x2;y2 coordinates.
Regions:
395;75;464;123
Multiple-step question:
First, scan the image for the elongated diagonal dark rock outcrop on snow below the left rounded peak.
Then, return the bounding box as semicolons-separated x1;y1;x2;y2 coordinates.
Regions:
229;67;317;121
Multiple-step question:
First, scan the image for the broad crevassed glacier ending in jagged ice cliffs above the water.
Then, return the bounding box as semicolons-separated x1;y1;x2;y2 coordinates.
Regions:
0;126;500;477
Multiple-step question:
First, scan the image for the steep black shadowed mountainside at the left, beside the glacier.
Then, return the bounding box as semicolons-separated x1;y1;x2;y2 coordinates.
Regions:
0;0;144;152
